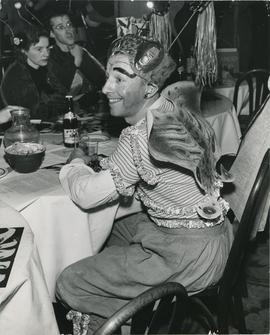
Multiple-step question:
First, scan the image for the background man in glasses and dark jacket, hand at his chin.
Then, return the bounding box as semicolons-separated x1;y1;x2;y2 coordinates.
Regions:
47;8;106;130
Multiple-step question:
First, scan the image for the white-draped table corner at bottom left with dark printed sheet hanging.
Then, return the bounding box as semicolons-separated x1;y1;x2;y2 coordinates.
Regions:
0;201;59;335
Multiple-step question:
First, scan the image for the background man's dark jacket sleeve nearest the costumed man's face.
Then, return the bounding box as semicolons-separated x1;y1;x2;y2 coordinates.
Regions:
80;49;106;90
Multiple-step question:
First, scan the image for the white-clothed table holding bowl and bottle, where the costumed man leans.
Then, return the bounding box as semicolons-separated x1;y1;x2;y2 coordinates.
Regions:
0;136;120;301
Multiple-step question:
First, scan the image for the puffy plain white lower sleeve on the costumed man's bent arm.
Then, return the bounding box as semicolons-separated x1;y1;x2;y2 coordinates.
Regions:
59;158;117;209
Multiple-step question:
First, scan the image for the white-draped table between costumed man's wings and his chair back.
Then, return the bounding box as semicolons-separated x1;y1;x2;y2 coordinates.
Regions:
201;93;241;155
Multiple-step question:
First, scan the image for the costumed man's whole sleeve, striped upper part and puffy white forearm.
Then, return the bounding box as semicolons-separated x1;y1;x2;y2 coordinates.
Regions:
59;135;140;208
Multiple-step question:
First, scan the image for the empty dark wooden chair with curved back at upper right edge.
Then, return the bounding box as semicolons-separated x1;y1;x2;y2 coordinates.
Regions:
233;69;270;132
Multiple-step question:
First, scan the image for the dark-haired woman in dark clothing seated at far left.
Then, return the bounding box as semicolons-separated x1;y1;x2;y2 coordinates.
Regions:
1;26;65;121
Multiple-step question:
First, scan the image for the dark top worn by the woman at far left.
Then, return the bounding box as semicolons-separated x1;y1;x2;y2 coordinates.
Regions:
1;61;65;121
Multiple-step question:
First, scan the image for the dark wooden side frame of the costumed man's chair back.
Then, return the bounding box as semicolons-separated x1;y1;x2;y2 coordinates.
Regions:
219;149;270;297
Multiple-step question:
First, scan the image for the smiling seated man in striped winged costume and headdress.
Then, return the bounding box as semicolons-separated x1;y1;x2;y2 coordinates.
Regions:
57;35;232;334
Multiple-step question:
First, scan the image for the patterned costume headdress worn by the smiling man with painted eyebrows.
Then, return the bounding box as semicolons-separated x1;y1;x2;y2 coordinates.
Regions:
108;34;176;87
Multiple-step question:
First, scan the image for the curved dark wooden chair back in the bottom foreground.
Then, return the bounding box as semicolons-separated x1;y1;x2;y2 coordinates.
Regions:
94;282;217;335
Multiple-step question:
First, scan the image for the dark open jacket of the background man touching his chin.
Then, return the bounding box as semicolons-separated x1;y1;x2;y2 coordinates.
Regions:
48;45;106;93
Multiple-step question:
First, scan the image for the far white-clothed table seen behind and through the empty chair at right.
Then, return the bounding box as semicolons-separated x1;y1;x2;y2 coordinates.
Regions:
208;82;249;115
